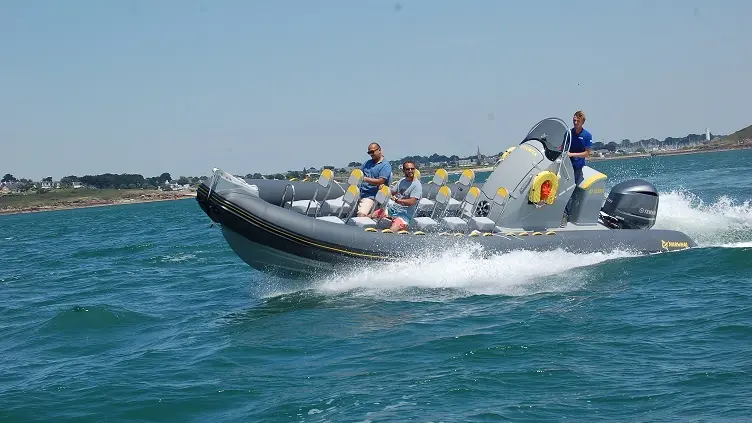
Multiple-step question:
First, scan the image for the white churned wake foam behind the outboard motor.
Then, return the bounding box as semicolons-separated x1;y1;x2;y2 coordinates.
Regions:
655;191;752;248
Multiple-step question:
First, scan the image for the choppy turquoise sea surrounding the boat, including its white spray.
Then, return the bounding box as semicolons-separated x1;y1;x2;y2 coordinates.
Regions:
0;151;752;422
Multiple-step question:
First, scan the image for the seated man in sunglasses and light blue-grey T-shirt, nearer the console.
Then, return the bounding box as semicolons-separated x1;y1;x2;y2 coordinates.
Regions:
372;160;423;232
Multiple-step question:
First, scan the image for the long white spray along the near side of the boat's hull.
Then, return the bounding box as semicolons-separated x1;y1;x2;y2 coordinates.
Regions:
316;248;632;300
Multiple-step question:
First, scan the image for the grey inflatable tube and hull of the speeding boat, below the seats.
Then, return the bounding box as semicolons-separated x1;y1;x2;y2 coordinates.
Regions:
196;184;695;278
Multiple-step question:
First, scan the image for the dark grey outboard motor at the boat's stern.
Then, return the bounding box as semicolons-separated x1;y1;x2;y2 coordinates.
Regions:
599;179;658;229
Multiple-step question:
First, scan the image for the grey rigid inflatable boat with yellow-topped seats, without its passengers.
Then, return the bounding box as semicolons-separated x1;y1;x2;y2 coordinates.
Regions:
196;118;696;277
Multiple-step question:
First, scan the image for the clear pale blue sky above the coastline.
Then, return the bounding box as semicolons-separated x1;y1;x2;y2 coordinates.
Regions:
0;0;752;180
